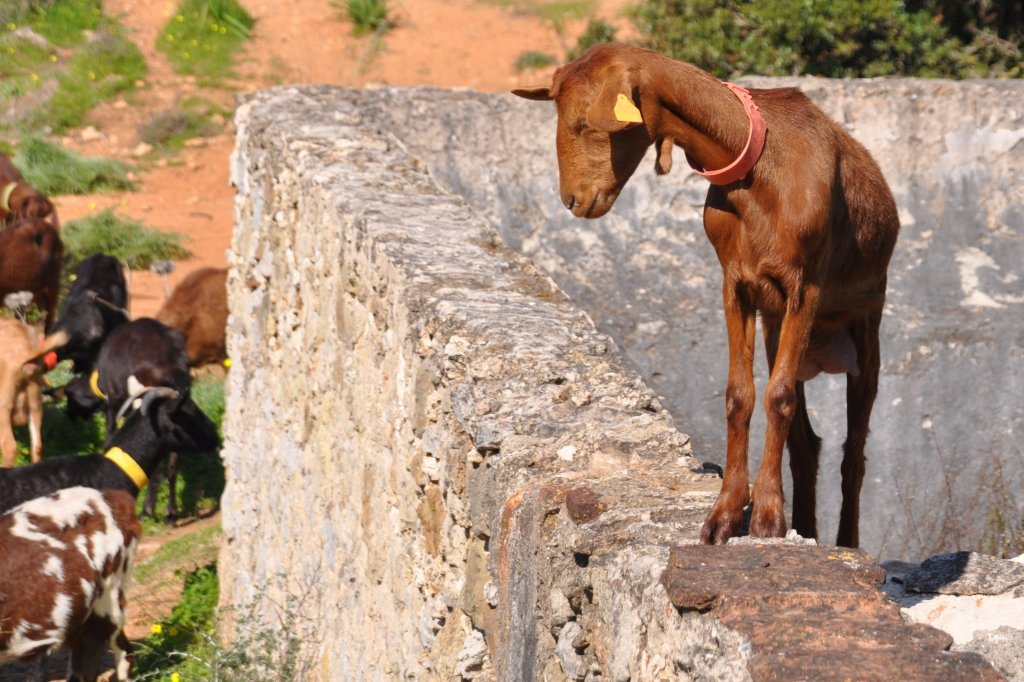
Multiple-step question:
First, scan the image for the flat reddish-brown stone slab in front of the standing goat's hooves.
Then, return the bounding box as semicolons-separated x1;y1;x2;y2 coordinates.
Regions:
662;544;1002;680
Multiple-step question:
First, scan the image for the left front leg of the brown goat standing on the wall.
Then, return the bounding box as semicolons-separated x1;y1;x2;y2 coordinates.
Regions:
700;279;757;545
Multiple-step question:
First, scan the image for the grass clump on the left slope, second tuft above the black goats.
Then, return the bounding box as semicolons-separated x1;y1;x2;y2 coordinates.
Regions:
13;137;135;195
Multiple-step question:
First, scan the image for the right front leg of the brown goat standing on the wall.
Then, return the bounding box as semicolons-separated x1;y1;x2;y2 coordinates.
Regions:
751;284;818;538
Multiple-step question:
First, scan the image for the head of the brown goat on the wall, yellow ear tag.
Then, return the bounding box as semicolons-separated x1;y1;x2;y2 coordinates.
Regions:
512;45;653;218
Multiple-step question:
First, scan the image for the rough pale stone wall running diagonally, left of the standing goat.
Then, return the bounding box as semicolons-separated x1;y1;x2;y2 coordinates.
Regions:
219;88;724;680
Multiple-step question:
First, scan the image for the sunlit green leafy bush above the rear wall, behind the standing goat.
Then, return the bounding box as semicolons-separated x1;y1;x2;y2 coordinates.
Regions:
634;0;1011;78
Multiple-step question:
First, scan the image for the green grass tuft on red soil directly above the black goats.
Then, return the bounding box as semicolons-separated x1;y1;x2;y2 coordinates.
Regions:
60;209;191;271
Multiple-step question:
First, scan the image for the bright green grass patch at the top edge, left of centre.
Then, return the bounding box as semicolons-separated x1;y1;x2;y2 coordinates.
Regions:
157;0;254;80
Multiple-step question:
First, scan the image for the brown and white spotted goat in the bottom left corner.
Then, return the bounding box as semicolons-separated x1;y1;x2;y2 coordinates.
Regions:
0;487;141;682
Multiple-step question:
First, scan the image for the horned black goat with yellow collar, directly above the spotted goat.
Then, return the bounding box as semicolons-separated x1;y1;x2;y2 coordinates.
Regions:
0;387;220;513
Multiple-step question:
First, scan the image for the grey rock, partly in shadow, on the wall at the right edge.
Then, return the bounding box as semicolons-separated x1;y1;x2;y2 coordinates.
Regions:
905;552;1024;593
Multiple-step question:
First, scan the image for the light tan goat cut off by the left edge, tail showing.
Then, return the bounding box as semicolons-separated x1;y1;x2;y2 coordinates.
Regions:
0;317;68;467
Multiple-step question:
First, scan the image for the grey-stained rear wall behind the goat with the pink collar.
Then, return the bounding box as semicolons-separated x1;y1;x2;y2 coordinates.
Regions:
366;79;1024;559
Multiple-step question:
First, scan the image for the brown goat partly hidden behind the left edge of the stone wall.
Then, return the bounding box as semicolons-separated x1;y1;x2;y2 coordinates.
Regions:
156;267;227;367
